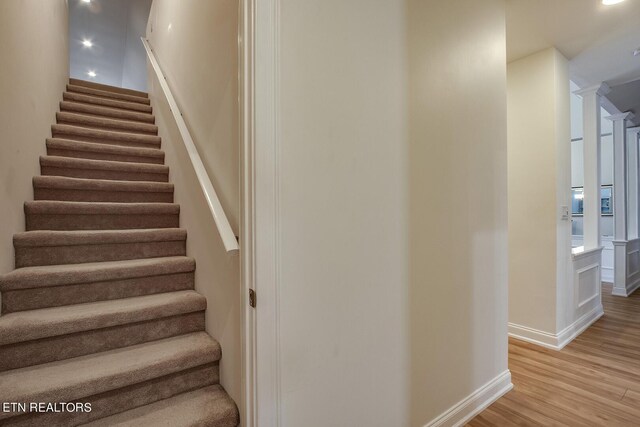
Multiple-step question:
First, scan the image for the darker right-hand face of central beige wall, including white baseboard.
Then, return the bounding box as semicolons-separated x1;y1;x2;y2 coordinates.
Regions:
408;0;510;426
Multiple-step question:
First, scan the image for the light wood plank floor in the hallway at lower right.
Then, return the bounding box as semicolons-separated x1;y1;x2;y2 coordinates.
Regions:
467;285;640;427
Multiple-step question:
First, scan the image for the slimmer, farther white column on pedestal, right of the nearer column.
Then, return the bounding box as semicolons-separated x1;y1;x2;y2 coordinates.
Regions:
607;113;632;295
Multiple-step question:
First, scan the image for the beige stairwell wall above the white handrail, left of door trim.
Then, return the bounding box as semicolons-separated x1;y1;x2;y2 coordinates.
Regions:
147;0;240;234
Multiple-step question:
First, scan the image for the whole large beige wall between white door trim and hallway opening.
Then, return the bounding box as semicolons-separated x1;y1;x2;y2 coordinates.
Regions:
272;0;507;427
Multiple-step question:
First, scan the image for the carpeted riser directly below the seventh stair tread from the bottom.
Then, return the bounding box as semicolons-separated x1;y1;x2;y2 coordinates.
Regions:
33;187;173;205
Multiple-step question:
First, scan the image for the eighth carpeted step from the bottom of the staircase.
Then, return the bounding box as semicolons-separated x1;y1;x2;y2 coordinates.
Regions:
40;156;169;182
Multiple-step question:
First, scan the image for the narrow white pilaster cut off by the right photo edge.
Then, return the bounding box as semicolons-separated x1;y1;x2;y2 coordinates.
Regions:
627;127;640;240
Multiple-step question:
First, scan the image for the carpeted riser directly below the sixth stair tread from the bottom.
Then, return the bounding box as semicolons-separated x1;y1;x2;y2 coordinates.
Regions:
26;214;180;231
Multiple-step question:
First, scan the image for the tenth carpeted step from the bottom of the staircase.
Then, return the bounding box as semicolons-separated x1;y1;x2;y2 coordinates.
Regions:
51;124;160;148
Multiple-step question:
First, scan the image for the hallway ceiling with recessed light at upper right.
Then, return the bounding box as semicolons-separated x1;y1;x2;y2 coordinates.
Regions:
507;0;640;124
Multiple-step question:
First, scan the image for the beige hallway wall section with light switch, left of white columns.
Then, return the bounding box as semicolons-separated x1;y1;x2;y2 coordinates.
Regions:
507;48;571;334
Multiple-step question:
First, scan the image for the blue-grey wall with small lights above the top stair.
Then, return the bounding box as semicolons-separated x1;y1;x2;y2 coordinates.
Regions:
68;0;151;92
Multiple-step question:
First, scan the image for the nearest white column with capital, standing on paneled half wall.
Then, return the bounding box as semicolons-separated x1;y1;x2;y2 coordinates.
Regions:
575;83;611;251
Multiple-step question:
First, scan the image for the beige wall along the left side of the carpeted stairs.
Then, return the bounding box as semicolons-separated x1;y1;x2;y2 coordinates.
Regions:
0;0;69;273
